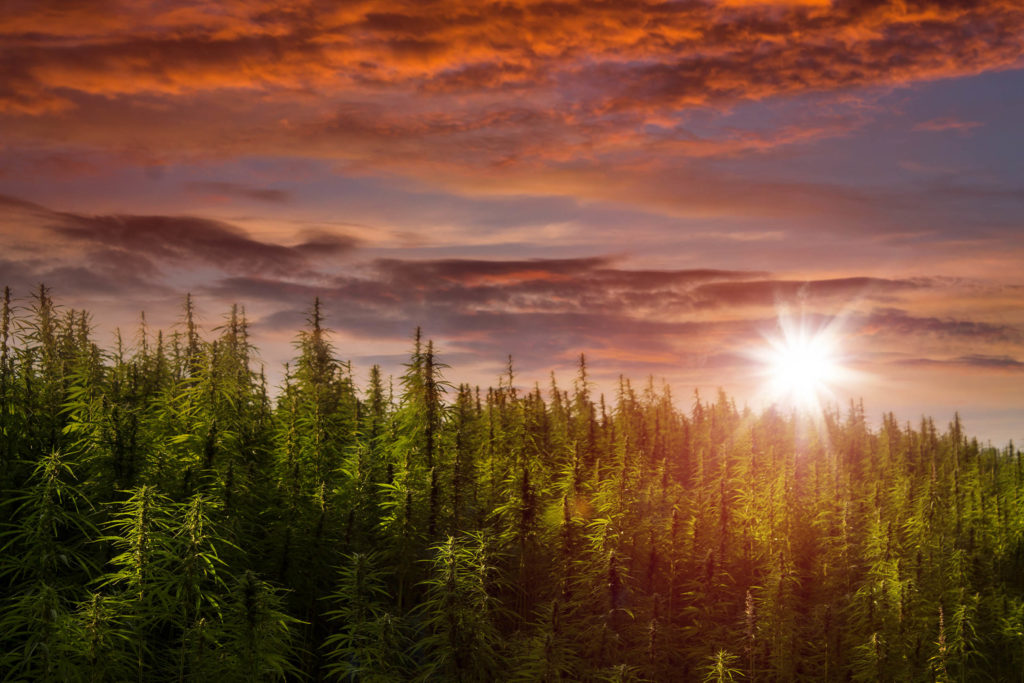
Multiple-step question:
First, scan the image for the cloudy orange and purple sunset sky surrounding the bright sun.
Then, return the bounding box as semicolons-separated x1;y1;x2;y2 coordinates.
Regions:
0;0;1024;445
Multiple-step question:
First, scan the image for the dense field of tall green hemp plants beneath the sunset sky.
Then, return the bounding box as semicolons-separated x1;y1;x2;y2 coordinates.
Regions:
0;288;1024;682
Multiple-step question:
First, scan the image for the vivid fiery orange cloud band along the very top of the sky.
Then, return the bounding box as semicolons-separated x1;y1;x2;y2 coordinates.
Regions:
0;0;1024;122
